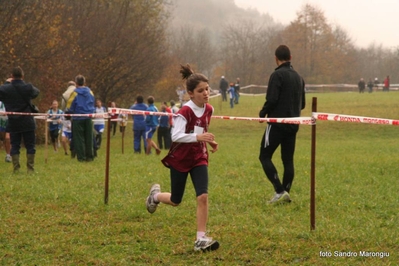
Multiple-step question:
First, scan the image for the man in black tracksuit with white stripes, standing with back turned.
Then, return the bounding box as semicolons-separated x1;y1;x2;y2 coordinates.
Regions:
259;45;305;203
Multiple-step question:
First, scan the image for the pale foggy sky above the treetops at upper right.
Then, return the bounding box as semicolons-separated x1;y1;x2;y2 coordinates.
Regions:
234;0;399;48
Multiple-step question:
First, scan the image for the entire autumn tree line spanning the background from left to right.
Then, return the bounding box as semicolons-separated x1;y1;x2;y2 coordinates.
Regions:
0;0;399;113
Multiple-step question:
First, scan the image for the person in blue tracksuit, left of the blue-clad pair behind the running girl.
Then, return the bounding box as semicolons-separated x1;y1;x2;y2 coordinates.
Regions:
130;95;148;153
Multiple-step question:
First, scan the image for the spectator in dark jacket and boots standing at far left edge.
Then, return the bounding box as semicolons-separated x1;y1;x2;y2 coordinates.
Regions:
0;67;40;173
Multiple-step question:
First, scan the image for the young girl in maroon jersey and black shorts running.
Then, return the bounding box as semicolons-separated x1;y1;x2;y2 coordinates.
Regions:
146;65;219;251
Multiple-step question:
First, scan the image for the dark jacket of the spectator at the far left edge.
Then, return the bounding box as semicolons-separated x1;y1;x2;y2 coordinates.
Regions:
0;80;40;133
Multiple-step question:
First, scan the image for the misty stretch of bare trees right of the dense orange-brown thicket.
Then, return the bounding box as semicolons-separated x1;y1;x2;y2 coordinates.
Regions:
171;0;399;88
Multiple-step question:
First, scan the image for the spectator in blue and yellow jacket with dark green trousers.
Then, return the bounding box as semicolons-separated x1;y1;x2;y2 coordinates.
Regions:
67;75;95;162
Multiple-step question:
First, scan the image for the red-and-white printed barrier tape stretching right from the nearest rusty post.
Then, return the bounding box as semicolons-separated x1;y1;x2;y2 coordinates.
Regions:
312;112;399;126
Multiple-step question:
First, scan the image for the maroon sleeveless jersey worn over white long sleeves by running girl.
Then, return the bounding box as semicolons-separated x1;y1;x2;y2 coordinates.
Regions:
162;104;213;172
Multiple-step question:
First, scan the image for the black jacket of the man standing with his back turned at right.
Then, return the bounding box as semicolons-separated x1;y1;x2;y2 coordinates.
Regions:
259;62;305;130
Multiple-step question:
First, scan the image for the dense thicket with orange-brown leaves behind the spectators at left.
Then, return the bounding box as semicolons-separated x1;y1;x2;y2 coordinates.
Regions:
0;0;168;110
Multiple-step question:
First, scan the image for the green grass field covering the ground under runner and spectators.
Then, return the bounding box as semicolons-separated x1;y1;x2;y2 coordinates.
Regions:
0;92;399;265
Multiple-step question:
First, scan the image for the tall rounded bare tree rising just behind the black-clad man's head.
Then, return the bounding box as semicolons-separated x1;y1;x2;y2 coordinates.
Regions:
281;4;356;83
